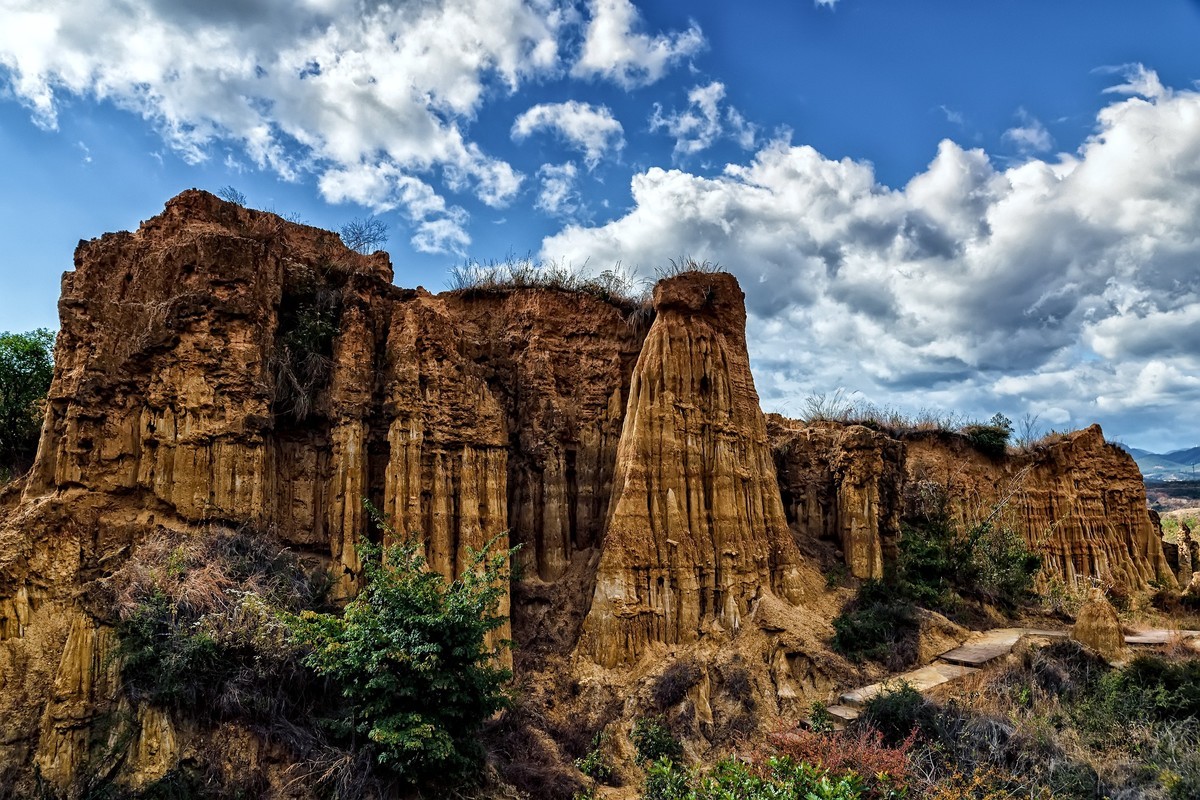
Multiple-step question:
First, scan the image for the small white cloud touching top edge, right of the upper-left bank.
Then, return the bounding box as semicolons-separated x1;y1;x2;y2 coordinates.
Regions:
571;0;704;89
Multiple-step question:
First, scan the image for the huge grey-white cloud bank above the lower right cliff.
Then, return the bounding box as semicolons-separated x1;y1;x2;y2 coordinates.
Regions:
542;70;1200;443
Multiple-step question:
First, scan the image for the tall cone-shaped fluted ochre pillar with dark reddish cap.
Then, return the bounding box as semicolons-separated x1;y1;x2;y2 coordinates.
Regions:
581;272;814;666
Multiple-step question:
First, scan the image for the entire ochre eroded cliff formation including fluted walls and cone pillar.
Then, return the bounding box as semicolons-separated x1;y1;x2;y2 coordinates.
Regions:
0;191;1174;787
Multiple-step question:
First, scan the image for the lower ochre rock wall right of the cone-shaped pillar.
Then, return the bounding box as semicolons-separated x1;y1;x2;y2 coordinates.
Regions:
772;419;1175;590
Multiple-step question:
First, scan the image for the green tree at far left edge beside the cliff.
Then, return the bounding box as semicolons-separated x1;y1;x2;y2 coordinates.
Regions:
0;329;54;473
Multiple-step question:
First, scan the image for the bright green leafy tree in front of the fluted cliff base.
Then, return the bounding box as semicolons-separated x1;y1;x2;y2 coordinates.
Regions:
292;513;511;786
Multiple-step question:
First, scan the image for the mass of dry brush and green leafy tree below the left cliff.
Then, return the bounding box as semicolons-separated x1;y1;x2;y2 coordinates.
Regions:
105;503;510;798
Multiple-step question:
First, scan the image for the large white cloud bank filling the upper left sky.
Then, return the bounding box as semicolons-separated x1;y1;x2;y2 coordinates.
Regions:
0;0;570;249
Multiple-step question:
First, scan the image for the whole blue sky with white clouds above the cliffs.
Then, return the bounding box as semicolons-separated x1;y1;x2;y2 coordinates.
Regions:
0;0;1200;450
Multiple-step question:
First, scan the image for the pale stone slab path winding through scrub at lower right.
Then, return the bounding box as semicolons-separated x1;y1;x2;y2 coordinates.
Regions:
826;627;1200;730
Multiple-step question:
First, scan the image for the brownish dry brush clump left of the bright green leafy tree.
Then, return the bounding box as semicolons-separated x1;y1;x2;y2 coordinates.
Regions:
112;528;325;721
